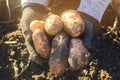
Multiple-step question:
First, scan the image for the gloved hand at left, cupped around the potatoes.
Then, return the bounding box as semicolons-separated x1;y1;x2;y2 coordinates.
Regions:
20;6;47;65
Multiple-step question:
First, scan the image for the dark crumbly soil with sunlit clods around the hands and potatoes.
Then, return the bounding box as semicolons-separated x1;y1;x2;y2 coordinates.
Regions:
0;7;120;80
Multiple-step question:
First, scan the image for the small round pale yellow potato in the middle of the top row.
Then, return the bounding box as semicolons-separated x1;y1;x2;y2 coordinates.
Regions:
45;14;63;35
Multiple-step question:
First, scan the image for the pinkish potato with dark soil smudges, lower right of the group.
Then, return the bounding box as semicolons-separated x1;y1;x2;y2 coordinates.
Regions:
68;38;90;70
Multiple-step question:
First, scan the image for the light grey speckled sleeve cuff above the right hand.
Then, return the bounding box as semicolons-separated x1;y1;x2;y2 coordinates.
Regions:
77;0;110;22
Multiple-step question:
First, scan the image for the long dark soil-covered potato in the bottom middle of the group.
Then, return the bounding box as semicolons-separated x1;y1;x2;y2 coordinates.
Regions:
49;32;69;76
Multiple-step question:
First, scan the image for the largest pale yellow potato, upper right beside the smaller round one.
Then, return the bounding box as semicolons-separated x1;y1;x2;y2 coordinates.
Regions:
61;10;85;37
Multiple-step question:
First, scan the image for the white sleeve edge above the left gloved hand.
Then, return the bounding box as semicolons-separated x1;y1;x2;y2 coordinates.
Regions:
21;0;48;6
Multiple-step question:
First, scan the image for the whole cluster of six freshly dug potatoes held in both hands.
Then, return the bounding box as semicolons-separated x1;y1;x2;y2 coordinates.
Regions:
30;10;89;76
